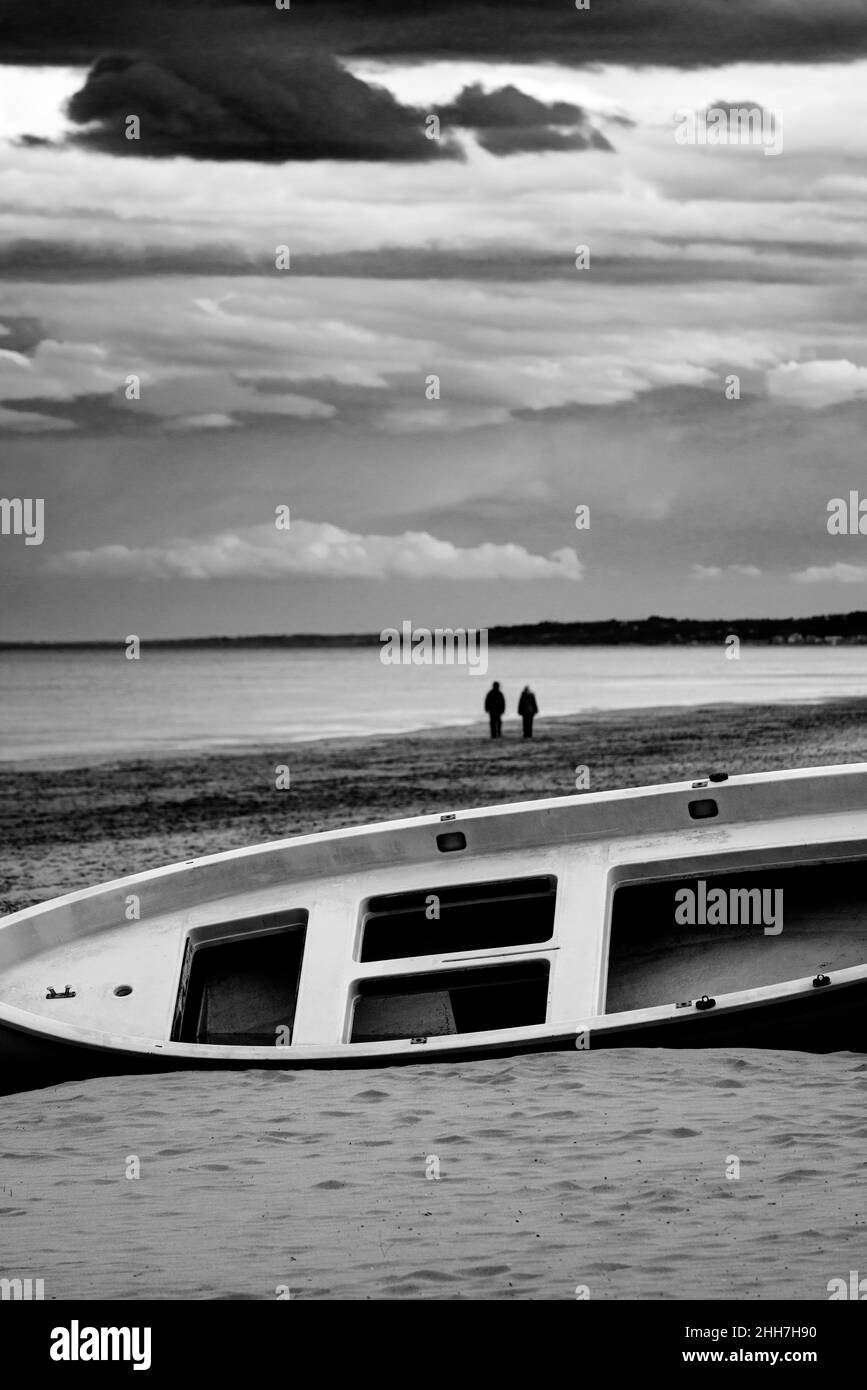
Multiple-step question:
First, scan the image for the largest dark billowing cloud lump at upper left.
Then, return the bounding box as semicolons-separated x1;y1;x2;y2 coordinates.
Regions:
68;51;461;163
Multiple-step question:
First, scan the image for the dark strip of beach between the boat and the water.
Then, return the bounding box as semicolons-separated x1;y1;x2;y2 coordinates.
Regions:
0;696;867;915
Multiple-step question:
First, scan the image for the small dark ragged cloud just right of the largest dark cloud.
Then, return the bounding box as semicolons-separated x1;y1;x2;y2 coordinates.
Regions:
438;85;611;154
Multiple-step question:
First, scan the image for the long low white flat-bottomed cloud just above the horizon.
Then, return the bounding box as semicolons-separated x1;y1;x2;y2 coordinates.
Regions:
46;520;584;582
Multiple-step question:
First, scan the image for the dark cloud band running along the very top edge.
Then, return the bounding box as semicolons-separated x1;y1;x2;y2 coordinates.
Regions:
0;0;867;68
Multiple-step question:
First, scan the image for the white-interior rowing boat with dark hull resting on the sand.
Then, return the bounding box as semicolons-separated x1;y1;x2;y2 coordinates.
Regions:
0;763;867;1091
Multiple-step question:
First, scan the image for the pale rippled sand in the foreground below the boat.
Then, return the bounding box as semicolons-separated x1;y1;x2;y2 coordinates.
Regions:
0;1048;867;1300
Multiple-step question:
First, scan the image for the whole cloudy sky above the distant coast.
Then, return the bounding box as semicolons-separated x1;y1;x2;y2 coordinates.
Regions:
0;0;867;641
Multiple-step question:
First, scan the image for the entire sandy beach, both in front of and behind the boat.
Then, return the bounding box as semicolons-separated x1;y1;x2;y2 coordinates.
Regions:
0;699;867;1300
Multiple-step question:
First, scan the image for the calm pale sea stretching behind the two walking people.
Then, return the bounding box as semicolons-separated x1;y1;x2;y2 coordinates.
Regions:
0;645;867;762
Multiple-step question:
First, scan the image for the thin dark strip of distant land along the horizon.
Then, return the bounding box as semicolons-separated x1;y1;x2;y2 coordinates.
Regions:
0;612;867;652
